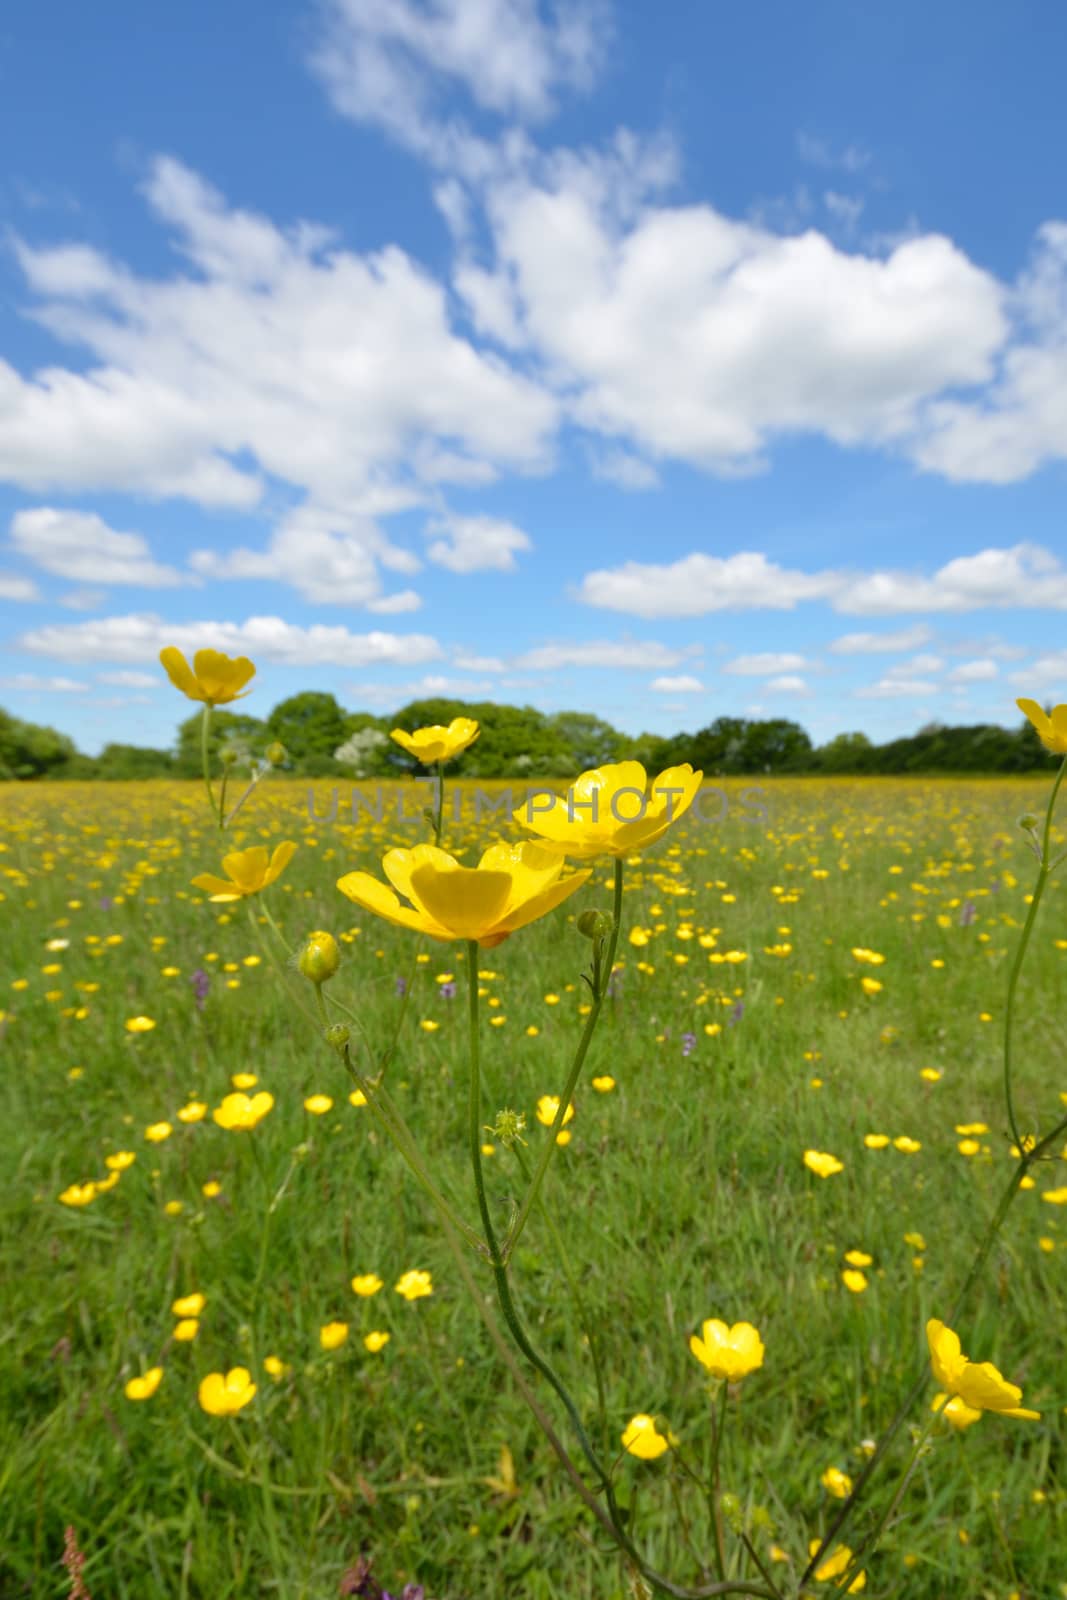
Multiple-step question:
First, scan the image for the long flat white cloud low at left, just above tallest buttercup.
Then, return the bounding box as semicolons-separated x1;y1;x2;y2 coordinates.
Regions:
18;613;442;672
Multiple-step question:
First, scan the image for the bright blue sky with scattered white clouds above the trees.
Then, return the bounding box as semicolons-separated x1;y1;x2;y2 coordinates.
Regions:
0;0;1067;750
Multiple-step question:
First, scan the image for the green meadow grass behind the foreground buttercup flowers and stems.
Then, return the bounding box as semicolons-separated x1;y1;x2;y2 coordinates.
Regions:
0;777;1067;1600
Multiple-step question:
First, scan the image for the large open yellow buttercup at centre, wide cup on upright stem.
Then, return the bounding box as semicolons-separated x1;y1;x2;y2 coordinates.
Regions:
338;840;589;949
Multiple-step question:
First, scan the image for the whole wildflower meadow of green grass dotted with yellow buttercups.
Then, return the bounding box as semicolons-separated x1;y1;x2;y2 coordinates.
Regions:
0;650;1067;1600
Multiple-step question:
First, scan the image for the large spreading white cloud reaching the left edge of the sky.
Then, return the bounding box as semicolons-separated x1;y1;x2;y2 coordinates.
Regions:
0;157;560;600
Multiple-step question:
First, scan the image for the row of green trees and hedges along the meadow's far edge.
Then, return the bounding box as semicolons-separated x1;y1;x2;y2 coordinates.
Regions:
0;691;1053;781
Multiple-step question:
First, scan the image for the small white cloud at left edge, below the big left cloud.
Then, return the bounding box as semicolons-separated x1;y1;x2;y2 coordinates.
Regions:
8;506;189;589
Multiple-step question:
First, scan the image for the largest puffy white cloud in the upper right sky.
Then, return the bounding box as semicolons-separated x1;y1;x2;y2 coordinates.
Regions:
480;160;1009;474
